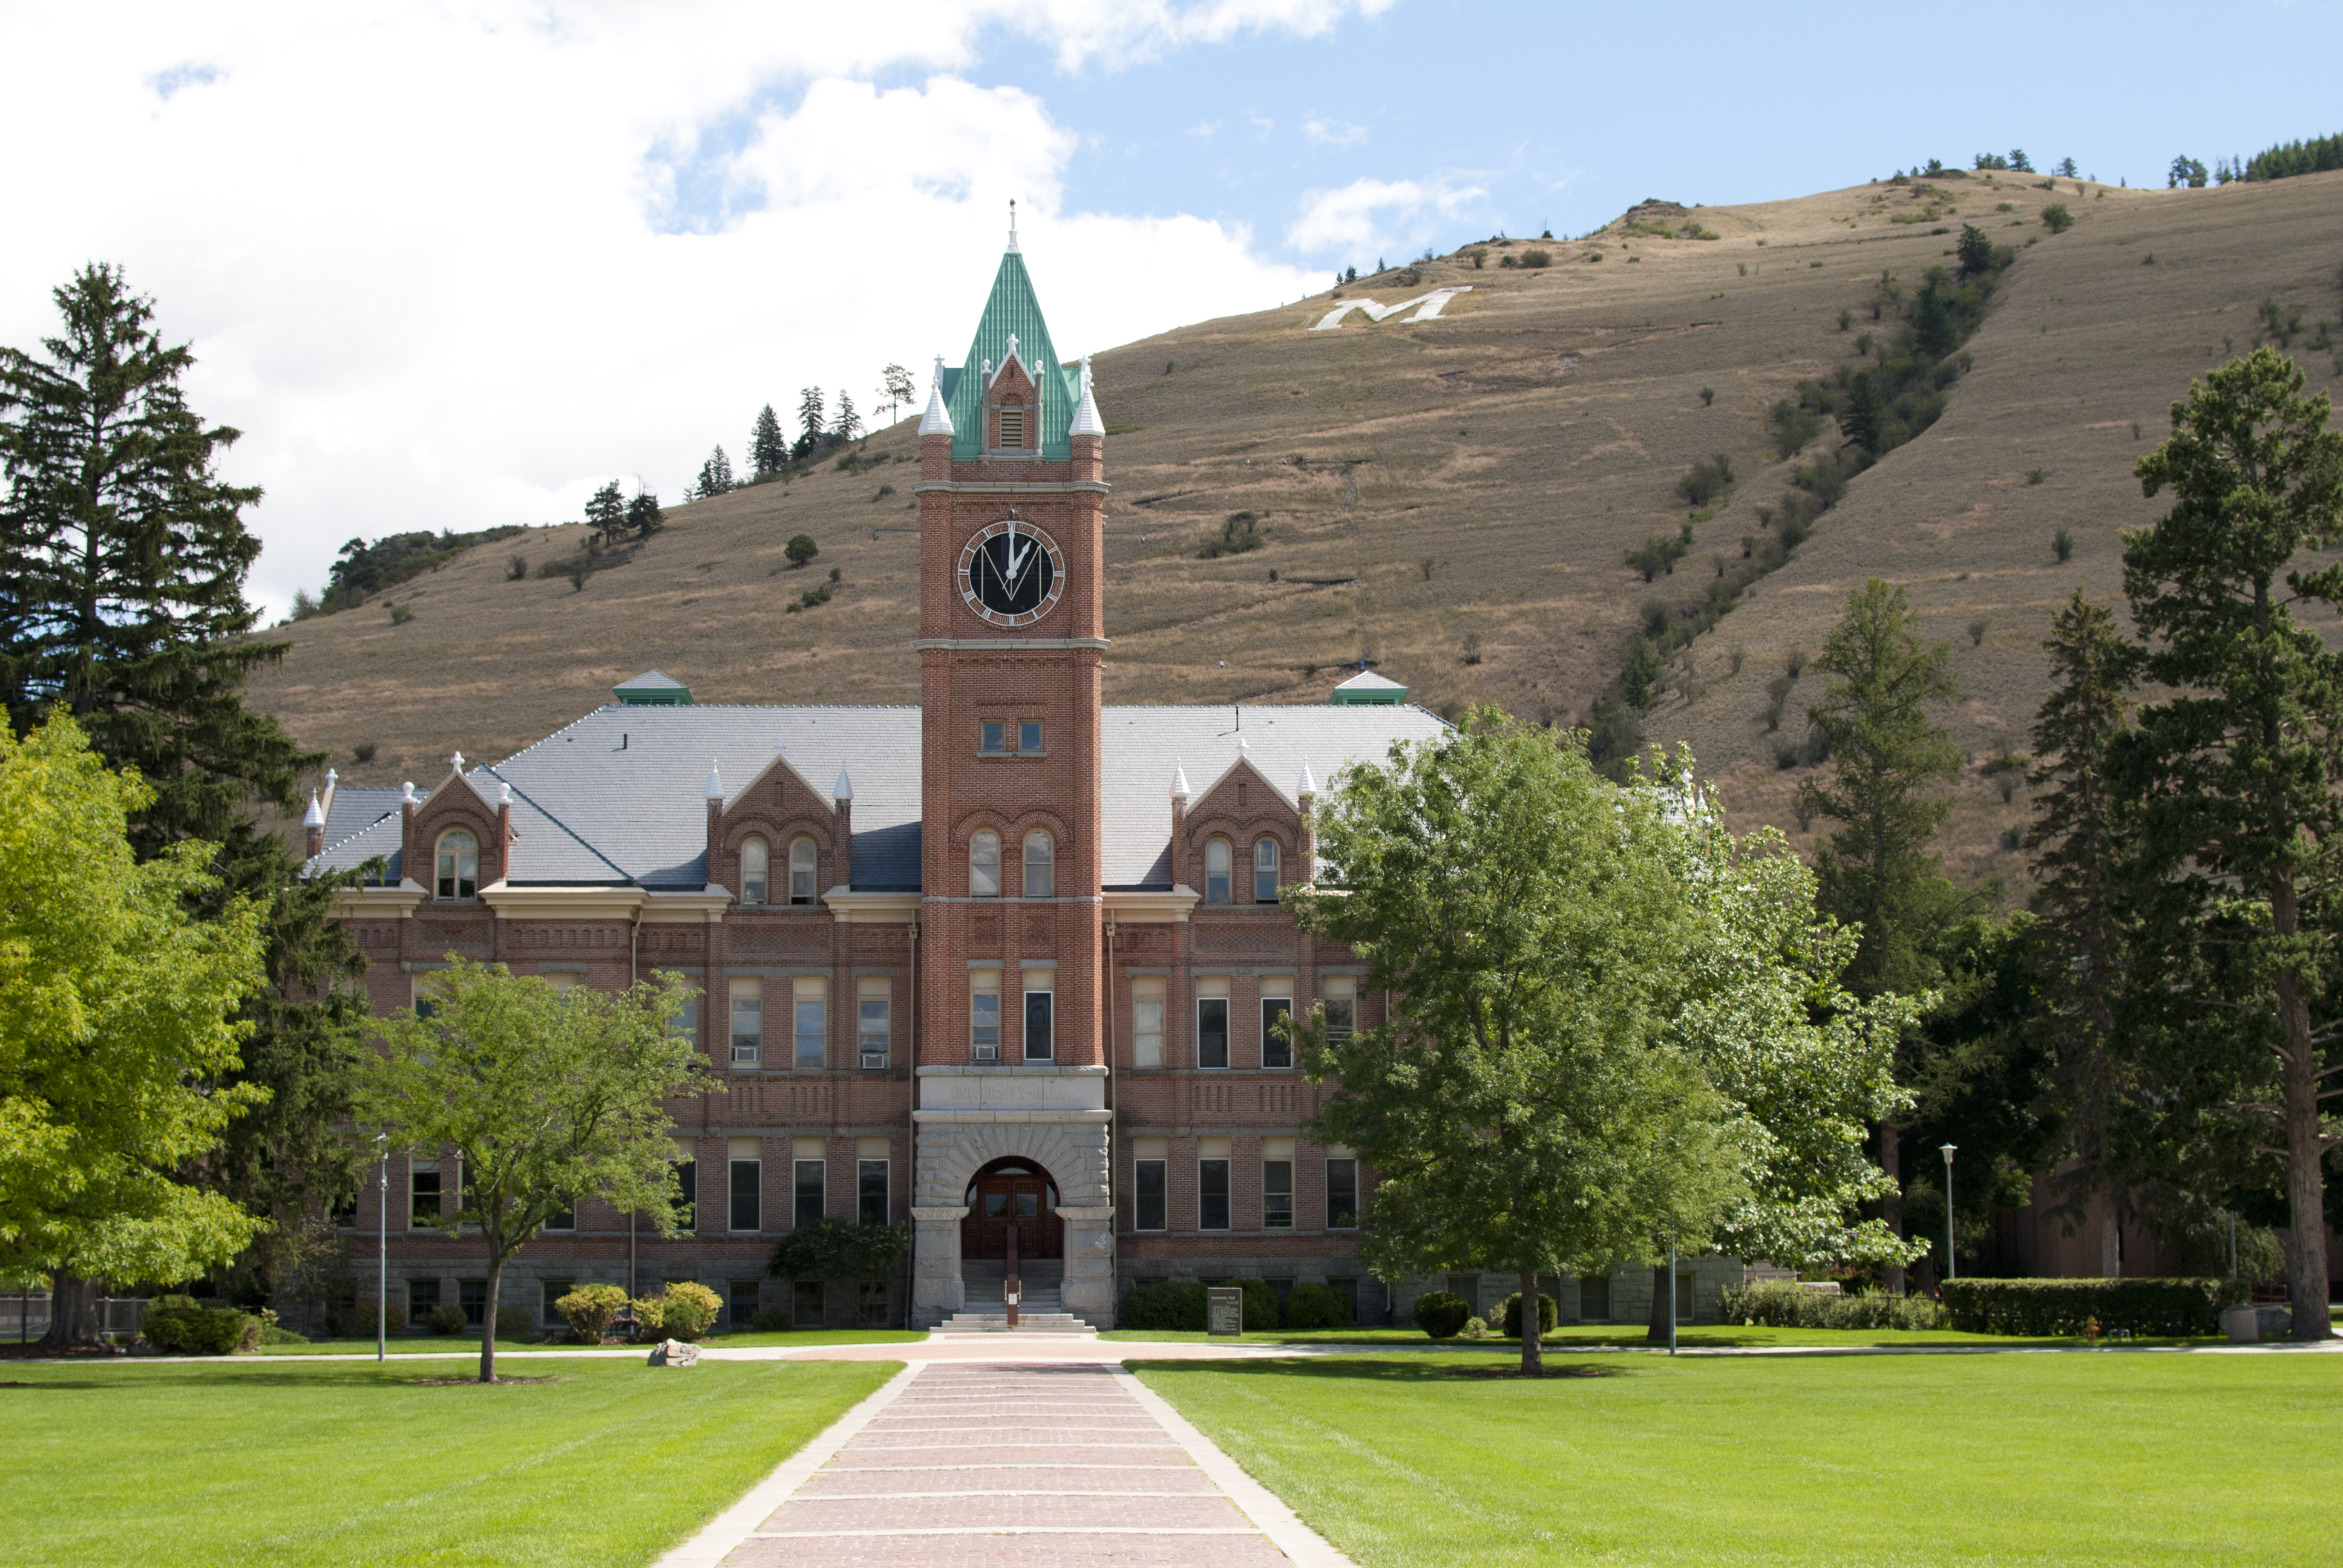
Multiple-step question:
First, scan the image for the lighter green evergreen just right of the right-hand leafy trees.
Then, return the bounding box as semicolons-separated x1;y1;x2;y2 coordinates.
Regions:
1797;577;1961;1289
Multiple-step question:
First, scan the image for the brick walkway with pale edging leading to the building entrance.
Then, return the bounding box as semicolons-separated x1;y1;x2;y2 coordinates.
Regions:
689;1364;1345;1568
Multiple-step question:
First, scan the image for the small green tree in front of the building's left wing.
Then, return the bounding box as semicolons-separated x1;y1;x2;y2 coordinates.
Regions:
358;956;703;1383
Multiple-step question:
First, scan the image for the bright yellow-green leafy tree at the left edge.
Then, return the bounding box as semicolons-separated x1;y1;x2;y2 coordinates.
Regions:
0;710;265;1345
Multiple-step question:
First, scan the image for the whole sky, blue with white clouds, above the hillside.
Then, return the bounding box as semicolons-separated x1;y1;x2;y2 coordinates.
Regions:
0;0;2343;609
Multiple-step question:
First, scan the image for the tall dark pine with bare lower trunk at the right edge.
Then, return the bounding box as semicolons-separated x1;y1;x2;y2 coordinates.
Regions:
2120;347;2343;1338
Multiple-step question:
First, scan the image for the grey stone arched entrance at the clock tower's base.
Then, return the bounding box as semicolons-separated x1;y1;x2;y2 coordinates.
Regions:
911;1067;1115;1329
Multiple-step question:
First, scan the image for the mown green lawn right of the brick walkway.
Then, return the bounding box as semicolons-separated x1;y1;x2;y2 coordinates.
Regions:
1134;1353;2343;1568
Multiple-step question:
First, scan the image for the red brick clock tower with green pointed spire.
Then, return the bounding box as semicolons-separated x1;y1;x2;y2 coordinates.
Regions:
914;225;1115;1322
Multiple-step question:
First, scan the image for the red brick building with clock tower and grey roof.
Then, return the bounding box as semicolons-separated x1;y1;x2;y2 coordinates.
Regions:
312;237;1441;1324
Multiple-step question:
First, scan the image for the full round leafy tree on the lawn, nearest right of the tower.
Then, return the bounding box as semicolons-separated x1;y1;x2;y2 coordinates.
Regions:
1296;708;1748;1373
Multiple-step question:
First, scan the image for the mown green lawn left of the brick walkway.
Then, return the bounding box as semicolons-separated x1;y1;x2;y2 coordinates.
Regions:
0;1359;900;1568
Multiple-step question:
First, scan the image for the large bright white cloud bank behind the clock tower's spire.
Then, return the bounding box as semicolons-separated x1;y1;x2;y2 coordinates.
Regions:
0;0;1358;607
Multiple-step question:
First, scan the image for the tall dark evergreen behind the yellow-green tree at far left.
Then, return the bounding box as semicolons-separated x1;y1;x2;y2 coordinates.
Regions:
0;265;365;1293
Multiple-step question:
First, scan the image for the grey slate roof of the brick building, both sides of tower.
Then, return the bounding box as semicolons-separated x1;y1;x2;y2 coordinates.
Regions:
309;703;1443;890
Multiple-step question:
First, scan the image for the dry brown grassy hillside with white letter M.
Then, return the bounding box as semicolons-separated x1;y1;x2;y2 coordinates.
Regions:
258;174;2343;874
